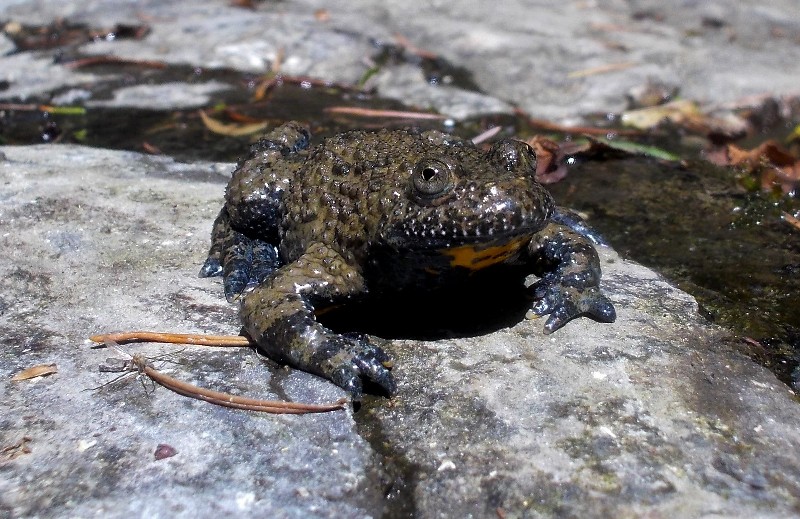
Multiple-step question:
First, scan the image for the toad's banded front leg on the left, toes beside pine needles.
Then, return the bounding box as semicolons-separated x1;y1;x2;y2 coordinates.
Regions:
241;244;395;400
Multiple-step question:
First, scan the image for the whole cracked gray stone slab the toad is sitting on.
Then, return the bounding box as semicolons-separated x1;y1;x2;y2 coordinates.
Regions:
0;145;800;518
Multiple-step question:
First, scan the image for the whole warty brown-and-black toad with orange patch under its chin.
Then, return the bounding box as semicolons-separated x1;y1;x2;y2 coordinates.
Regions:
201;123;615;399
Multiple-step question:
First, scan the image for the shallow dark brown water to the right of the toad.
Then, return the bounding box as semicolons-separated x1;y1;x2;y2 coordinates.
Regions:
548;157;800;387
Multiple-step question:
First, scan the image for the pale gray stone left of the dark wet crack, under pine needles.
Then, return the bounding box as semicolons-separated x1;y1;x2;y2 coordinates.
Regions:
0;147;380;517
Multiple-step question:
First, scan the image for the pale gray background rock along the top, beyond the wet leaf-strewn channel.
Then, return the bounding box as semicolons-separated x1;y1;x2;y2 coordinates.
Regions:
0;0;800;122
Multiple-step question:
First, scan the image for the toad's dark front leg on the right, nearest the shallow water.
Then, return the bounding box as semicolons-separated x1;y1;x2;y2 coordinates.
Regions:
528;223;617;333
